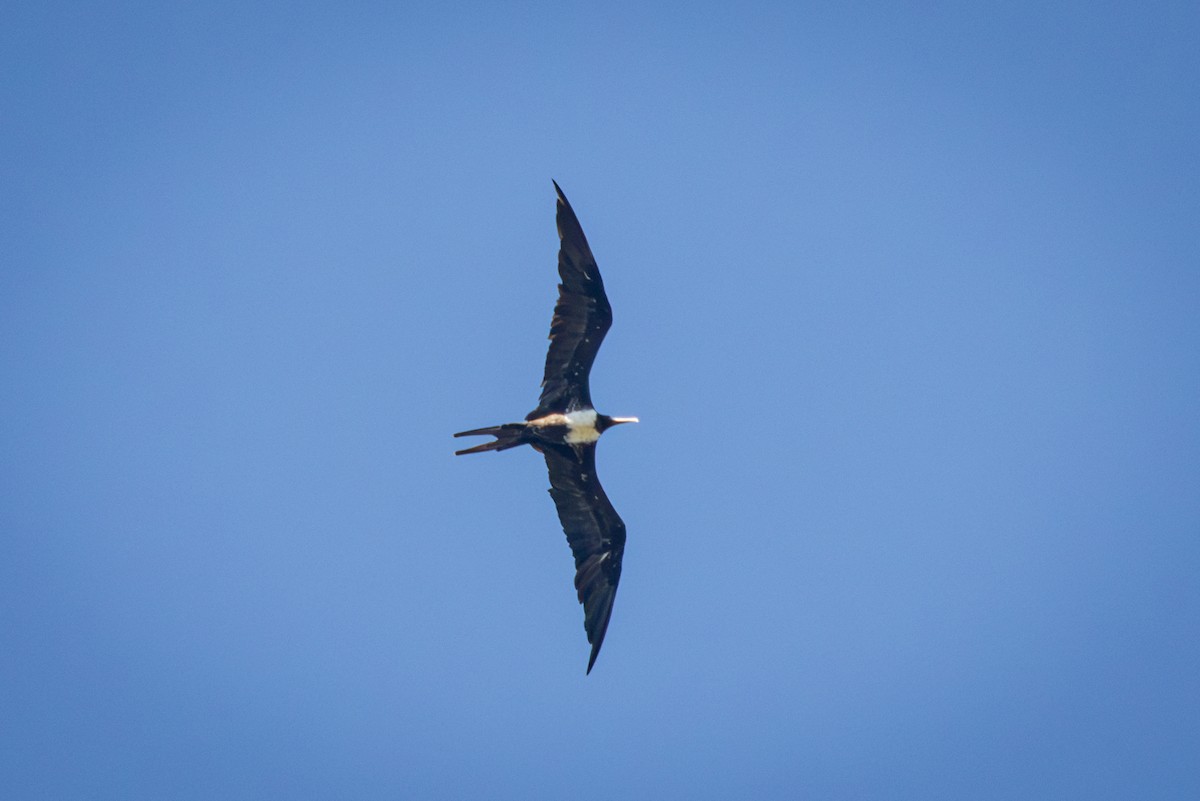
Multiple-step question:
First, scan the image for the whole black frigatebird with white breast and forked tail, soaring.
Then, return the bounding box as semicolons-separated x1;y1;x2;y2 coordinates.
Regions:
455;182;637;673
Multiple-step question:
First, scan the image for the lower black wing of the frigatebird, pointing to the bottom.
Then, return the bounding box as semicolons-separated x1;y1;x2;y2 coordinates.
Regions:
542;445;625;673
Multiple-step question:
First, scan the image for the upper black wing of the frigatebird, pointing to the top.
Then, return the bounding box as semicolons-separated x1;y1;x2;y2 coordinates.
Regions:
526;183;612;420
